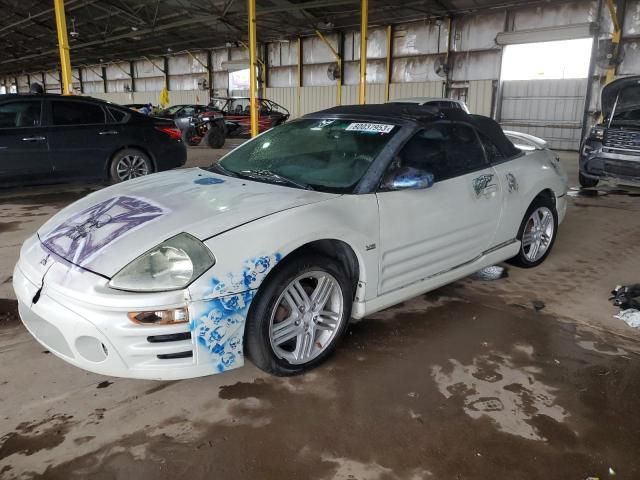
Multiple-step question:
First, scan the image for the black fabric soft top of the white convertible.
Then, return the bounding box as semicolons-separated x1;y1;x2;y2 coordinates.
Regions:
308;103;521;158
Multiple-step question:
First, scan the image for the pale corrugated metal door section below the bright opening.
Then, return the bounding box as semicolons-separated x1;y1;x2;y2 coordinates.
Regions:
500;78;587;150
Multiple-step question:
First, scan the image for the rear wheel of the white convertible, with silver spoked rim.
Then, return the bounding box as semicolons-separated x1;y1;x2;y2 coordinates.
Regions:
509;197;558;268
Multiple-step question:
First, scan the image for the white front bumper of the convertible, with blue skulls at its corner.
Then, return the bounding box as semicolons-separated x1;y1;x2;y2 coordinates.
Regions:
13;238;244;380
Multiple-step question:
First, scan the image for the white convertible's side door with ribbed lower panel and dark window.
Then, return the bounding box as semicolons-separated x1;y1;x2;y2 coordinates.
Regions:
377;121;502;294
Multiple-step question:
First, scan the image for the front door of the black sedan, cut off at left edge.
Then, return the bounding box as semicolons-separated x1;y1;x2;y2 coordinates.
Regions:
0;98;53;182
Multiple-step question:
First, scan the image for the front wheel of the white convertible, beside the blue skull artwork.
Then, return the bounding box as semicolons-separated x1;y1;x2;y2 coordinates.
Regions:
245;254;353;376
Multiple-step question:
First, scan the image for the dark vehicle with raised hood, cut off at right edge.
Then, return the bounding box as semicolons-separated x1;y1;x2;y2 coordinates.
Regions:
580;75;640;187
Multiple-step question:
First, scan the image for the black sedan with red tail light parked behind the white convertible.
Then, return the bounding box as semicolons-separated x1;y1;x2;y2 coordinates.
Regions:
0;94;187;186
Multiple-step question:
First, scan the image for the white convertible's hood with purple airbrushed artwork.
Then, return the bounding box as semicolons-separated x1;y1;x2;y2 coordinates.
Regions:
38;168;338;277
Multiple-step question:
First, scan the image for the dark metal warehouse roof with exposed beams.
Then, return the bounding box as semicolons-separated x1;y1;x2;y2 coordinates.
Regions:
0;0;546;74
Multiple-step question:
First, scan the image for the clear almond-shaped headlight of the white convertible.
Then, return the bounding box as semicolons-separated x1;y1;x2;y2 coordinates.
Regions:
109;233;216;292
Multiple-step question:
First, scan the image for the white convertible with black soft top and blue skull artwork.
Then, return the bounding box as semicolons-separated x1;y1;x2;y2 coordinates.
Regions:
13;105;567;380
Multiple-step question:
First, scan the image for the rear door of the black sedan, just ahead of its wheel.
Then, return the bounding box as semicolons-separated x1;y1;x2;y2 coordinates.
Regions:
48;99;122;178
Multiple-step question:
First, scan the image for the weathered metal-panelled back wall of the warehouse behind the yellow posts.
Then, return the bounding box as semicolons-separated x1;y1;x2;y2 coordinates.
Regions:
0;0;640;152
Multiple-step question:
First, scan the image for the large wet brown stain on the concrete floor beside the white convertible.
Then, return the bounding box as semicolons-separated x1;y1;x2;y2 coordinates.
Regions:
36;293;640;480
